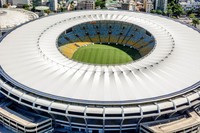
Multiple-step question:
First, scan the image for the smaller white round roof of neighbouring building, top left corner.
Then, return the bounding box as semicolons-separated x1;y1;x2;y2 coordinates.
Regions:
0;8;38;30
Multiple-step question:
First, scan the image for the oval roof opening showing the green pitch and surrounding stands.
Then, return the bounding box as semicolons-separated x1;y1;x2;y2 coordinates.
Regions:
57;20;155;65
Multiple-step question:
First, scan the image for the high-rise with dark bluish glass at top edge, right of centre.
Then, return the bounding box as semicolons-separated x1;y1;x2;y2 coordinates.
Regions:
154;0;168;11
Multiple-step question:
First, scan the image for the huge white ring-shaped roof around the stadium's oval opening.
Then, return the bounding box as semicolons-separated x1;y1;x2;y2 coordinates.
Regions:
0;10;200;103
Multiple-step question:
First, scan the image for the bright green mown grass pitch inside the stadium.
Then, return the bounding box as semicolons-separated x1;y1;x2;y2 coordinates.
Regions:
72;44;133;65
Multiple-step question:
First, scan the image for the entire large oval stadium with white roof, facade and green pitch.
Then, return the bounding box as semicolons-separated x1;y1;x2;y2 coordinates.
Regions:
0;10;200;133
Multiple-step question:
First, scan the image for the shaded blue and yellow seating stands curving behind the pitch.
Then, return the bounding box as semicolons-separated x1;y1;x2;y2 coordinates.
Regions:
58;21;155;55
